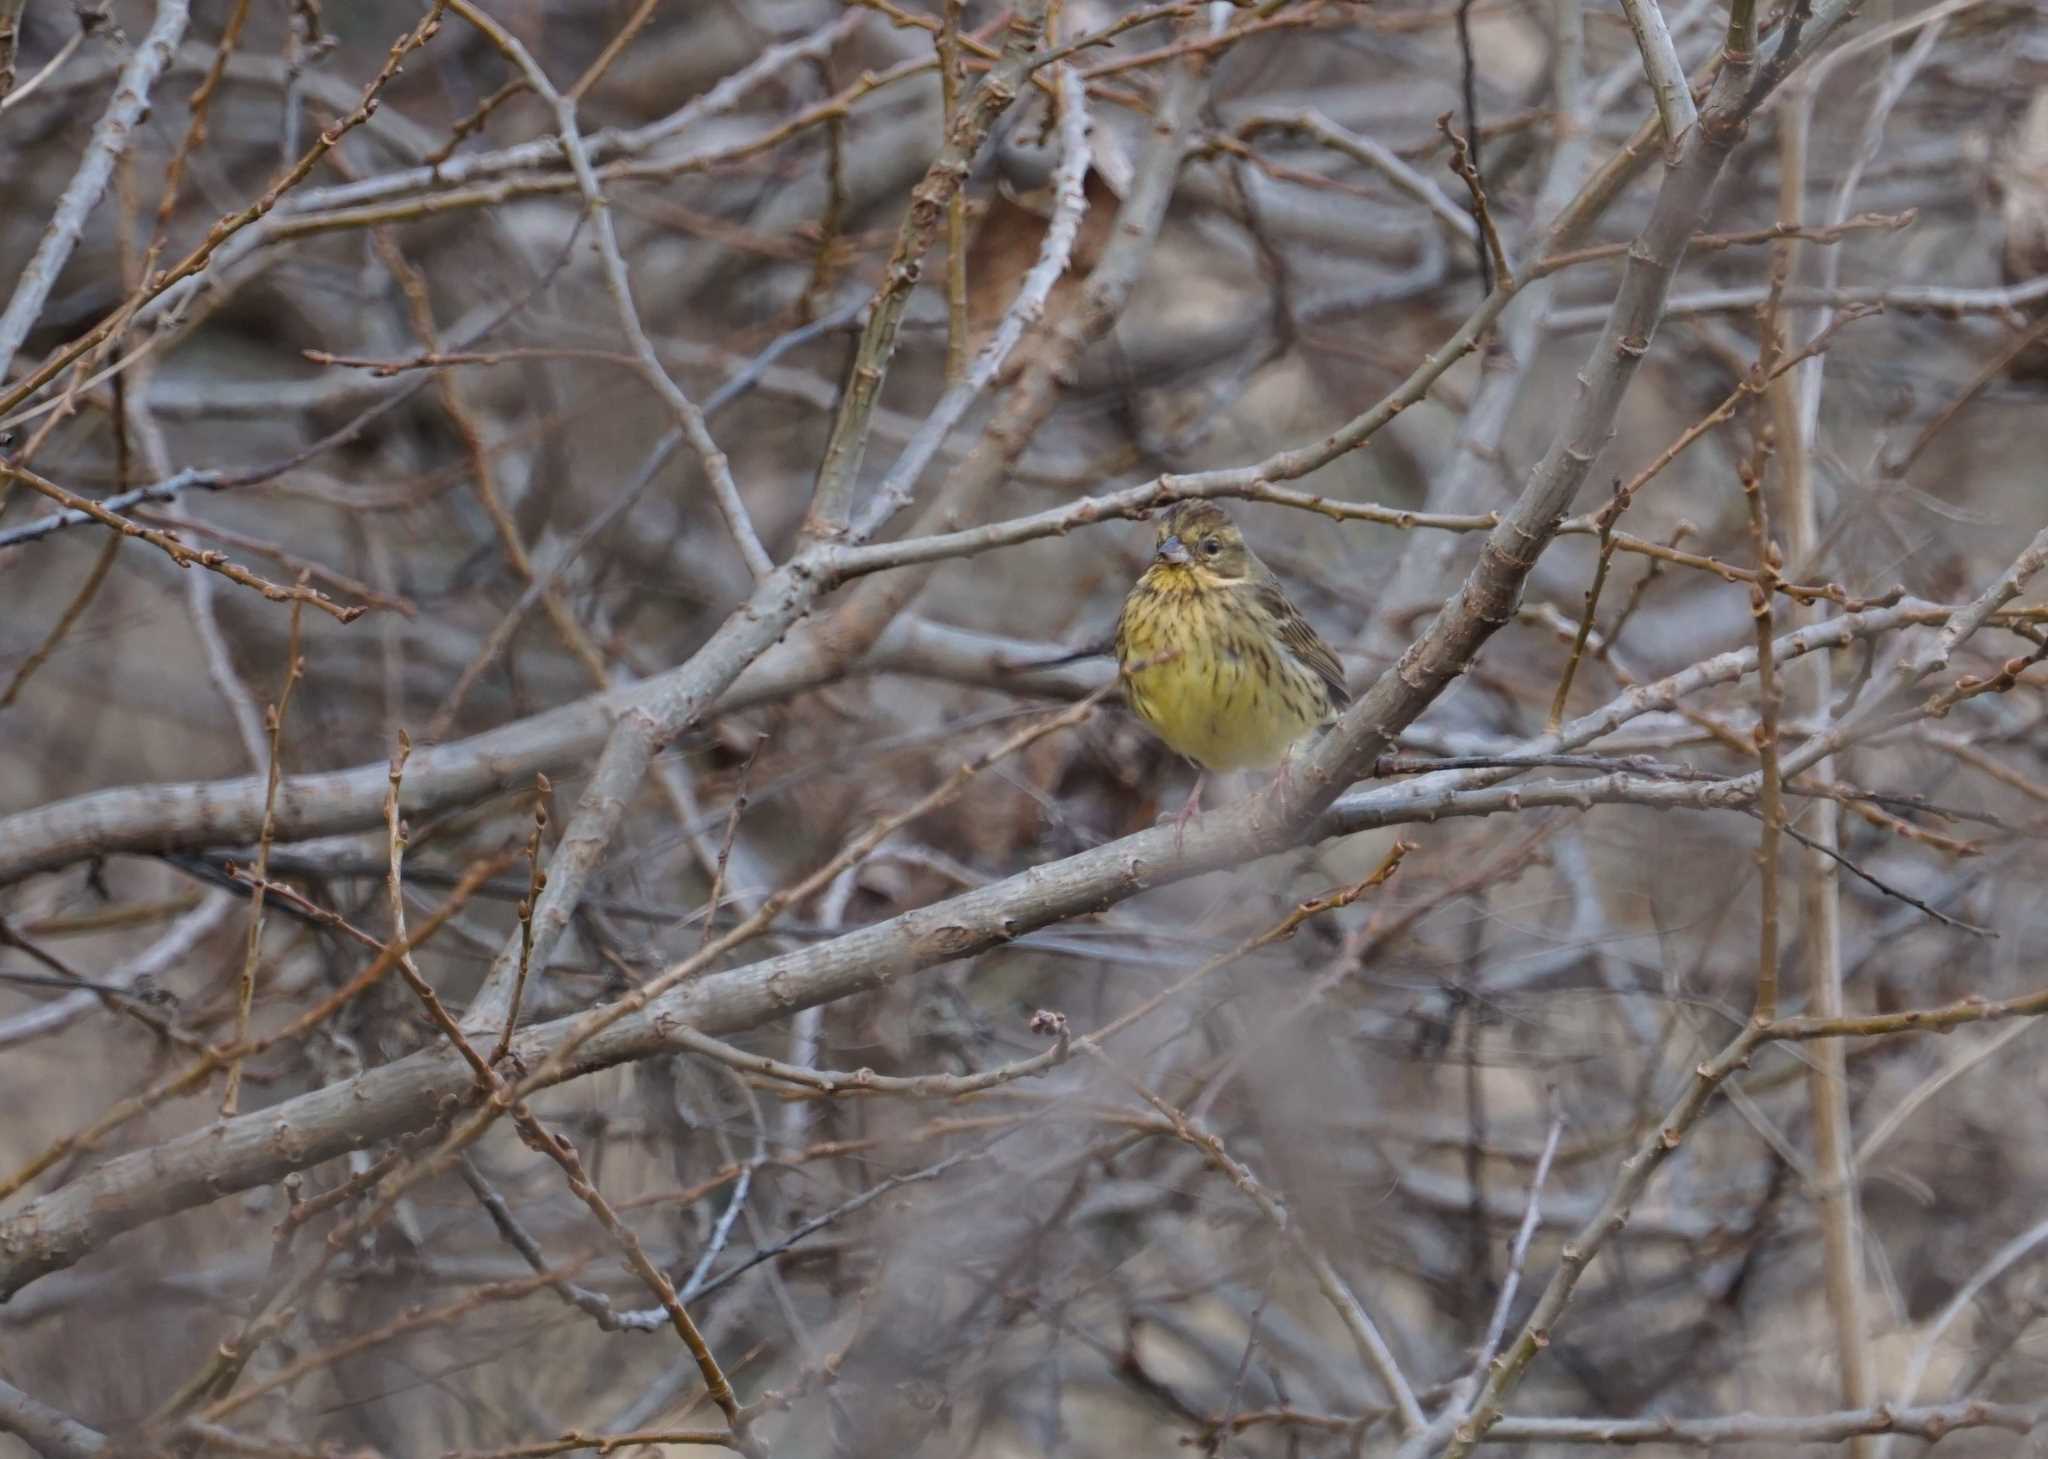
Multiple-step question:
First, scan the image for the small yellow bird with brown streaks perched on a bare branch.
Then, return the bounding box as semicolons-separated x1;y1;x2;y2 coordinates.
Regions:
1116;500;1352;830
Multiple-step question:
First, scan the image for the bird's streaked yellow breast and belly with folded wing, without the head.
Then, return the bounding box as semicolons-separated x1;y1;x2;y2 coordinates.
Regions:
1116;566;1325;770
